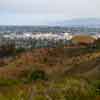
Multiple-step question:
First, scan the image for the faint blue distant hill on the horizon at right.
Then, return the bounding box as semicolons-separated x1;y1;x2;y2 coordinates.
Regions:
52;18;100;28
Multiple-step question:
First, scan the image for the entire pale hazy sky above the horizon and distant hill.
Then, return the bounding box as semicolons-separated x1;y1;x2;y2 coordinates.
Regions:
0;0;100;25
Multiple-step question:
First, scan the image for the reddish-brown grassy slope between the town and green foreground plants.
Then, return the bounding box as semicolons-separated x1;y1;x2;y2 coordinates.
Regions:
0;48;100;78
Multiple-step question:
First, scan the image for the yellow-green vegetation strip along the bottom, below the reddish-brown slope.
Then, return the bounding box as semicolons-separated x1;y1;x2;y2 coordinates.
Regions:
0;77;98;100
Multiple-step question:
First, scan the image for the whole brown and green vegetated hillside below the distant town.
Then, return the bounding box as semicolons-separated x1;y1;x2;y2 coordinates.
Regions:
0;38;100;100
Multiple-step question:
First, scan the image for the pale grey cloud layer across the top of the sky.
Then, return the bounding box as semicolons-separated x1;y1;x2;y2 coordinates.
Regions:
0;0;100;16
